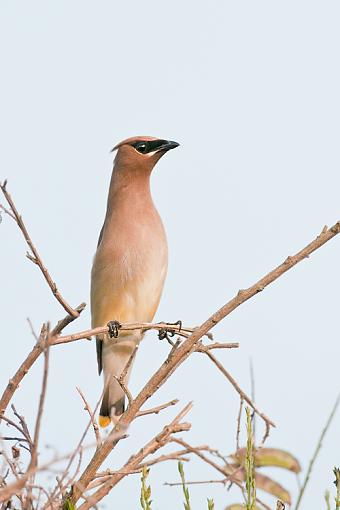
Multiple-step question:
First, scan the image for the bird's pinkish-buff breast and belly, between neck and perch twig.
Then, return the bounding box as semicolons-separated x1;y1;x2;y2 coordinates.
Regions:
91;217;167;327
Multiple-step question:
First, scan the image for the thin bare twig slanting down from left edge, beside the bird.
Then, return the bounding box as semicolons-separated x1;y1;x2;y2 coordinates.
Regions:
0;181;79;318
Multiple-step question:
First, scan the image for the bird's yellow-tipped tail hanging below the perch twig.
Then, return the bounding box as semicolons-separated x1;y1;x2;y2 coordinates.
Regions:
99;336;138;427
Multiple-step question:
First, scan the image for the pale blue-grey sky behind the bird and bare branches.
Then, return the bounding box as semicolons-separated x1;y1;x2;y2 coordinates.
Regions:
0;0;340;510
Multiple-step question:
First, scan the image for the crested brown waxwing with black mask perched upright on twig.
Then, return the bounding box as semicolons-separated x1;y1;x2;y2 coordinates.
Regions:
91;136;179;427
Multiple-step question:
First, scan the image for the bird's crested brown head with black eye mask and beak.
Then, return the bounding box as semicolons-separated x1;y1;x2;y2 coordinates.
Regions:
112;136;179;172
